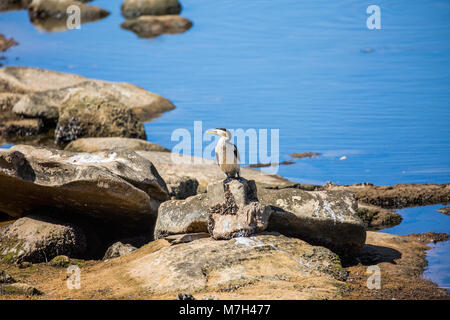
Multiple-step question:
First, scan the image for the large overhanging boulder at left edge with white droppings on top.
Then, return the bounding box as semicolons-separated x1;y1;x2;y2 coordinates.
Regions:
0;145;168;234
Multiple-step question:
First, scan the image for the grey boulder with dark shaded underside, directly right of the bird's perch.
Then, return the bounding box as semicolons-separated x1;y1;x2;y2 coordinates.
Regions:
258;188;366;257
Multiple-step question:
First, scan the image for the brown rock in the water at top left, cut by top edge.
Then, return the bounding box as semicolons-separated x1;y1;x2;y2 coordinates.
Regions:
28;0;109;31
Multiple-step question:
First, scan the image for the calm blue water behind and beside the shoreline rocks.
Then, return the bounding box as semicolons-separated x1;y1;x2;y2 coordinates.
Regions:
0;0;450;285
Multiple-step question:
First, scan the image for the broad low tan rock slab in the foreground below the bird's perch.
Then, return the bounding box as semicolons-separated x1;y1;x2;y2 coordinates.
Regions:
127;233;346;299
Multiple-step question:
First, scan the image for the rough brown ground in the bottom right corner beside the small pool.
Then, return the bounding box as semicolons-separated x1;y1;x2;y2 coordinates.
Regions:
342;232;450;300
